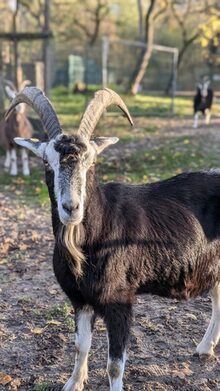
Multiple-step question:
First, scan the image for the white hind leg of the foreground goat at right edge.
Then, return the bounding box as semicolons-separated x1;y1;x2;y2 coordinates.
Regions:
196;283;220;355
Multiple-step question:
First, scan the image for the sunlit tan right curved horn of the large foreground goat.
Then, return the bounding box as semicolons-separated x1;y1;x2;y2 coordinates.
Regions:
77;88;133;139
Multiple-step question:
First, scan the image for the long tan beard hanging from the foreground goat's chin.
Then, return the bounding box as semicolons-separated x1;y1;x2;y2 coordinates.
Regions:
59;223;85;278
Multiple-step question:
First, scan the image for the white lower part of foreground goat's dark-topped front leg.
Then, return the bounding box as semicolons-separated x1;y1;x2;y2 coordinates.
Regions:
107;352;126;391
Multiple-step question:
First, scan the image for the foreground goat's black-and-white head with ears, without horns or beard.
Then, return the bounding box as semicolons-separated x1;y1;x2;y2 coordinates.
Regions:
14;134;118;226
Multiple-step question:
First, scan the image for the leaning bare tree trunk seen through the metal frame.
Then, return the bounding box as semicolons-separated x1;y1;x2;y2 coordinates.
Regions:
129;0;156;95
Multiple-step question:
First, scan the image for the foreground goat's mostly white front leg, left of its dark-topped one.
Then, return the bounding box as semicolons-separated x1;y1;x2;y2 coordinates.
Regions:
63;307;94;391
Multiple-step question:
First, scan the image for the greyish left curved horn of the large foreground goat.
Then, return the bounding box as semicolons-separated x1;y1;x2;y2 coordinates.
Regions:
5;87;62;139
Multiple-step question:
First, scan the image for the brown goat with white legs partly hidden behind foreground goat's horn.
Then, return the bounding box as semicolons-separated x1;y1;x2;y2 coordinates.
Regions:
0;80;33;176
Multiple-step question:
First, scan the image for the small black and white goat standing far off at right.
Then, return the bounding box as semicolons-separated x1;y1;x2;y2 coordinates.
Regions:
193;78;213;128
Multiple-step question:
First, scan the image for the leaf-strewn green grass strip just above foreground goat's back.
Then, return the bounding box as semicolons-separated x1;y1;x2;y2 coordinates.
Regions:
97;137;219;183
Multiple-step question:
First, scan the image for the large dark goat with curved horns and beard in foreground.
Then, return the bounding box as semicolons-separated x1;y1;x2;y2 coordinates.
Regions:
8;87;220;391
